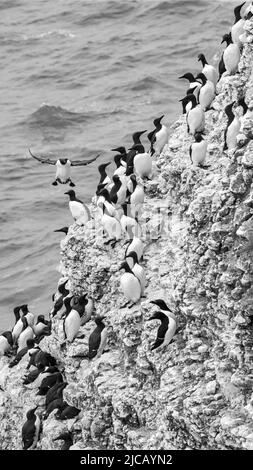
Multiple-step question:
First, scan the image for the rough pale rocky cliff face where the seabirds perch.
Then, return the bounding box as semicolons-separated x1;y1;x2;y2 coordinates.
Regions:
0;15;253;450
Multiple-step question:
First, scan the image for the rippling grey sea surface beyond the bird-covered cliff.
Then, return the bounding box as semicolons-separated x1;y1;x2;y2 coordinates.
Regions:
0;0;240;329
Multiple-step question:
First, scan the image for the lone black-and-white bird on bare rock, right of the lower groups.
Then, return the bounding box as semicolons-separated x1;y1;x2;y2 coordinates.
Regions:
148;311;177;351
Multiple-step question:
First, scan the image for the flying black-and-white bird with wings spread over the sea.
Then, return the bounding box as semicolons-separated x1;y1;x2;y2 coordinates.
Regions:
29;149;100;186
